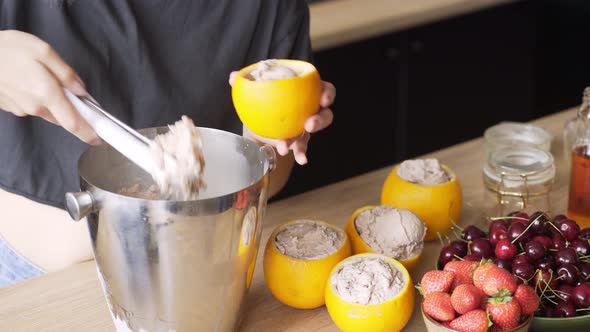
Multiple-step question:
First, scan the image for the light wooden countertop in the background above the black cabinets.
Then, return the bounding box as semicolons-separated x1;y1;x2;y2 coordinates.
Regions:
309;0;515;51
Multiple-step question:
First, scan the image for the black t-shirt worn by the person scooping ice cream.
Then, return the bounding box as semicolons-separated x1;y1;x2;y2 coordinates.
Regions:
0;0;311;207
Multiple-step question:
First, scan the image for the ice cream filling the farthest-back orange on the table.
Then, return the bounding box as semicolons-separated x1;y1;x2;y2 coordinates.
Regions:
397;159;451;186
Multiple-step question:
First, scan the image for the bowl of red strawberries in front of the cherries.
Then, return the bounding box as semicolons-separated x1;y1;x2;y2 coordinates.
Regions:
417;260;540;332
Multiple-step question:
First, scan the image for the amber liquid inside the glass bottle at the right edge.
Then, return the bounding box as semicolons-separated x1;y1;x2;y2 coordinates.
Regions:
568;146;590;228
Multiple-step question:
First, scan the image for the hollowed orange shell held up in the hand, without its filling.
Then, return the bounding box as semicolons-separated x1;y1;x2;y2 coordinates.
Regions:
232;59;322;139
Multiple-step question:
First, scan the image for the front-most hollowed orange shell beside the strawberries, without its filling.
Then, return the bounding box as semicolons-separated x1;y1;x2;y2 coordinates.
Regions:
325;253;415;332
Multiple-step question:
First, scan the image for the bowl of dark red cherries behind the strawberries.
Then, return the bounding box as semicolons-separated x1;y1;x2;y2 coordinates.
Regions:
436;211;590;331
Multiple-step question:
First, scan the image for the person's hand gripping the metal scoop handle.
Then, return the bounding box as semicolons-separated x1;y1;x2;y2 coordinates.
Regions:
0;30;100;144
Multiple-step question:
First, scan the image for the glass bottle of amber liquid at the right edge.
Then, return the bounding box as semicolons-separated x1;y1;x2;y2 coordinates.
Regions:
567;87;590;228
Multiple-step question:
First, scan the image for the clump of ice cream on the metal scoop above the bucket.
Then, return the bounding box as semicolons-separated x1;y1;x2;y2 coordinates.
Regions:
150;115;206;200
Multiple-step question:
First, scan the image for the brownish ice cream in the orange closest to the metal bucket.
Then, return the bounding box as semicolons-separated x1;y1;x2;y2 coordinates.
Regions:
275;220;344;260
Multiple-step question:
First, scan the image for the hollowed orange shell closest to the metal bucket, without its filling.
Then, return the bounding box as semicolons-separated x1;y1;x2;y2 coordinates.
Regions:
262;220;350;309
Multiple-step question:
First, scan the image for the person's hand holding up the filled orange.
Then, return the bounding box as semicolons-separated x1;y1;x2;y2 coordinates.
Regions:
229;72;336;165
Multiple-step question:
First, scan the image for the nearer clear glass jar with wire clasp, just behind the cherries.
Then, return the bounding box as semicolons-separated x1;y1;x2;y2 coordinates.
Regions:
483;146;555;217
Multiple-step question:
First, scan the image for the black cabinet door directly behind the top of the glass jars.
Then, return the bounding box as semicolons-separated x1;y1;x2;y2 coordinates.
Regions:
402;1;536;158
